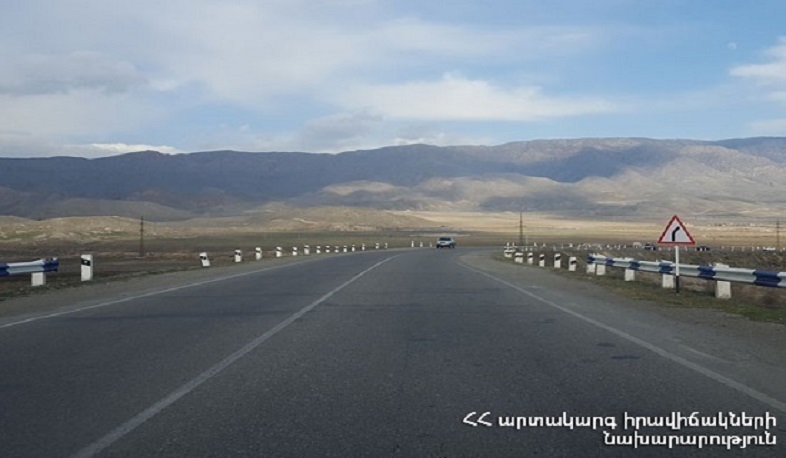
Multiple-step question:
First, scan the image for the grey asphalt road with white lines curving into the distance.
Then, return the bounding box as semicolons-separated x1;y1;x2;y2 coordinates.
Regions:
0;249;786;457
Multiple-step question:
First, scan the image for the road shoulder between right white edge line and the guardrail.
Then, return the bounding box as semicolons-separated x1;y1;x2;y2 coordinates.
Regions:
459;251;786;416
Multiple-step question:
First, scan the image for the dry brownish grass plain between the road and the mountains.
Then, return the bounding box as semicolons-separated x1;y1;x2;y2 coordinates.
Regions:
0;209;786;312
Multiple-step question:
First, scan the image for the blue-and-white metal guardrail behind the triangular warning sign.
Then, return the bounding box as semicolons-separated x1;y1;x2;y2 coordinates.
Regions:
587;254;786;288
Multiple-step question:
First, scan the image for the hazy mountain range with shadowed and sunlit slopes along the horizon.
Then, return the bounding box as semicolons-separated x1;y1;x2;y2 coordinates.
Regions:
0;137;786;221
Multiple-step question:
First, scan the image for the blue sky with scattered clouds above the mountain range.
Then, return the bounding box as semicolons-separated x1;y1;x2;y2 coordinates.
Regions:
0;0;786;157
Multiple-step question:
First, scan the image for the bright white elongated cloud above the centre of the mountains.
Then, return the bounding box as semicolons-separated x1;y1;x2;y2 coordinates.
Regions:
335;74;616;121
